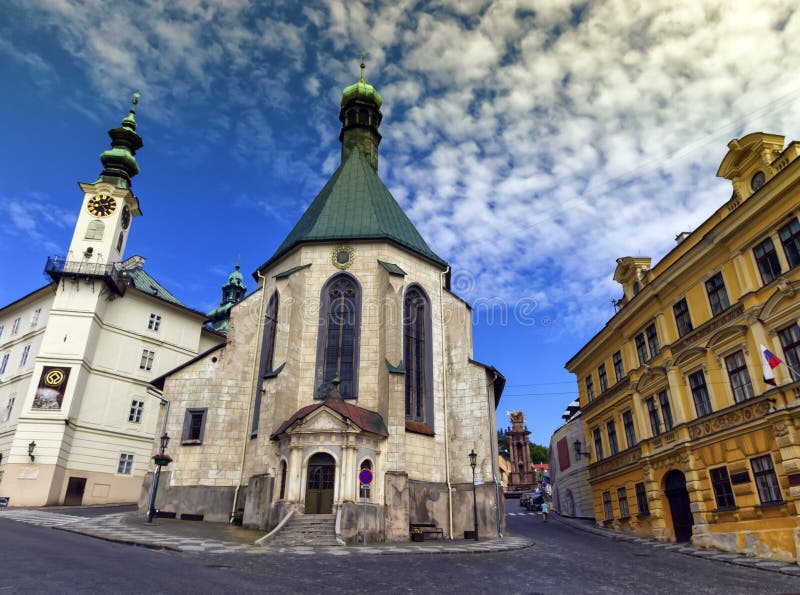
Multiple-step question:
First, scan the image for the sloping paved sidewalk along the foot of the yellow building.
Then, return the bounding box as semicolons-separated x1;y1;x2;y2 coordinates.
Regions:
550;513;800;577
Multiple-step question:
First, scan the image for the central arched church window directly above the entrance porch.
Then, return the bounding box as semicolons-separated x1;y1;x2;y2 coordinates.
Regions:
316;273;361;399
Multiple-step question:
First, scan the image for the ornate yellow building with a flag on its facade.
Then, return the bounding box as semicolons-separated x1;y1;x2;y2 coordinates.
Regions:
566;133;800;561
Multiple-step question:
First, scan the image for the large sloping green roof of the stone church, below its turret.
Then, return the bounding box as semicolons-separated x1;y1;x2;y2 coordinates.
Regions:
259;149;447;270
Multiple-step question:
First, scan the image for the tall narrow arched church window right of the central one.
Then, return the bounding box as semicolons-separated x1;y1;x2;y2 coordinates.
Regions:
403;286;433;429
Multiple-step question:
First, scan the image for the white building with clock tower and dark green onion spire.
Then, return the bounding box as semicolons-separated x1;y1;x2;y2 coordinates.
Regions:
0;99;224;506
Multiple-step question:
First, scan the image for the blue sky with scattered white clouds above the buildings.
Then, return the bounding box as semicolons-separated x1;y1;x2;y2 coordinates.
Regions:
0;0;800;445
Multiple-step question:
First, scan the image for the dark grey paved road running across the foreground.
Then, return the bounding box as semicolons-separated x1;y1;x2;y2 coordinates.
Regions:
0;505;800;595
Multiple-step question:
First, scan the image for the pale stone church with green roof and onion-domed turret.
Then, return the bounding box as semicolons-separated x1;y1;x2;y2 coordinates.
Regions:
146;64;505;543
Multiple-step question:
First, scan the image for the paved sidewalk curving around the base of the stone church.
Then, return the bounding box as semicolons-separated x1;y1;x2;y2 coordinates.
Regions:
42;510;533;556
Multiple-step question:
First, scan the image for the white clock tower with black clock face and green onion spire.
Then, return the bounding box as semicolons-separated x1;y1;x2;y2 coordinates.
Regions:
67;93;143;265
